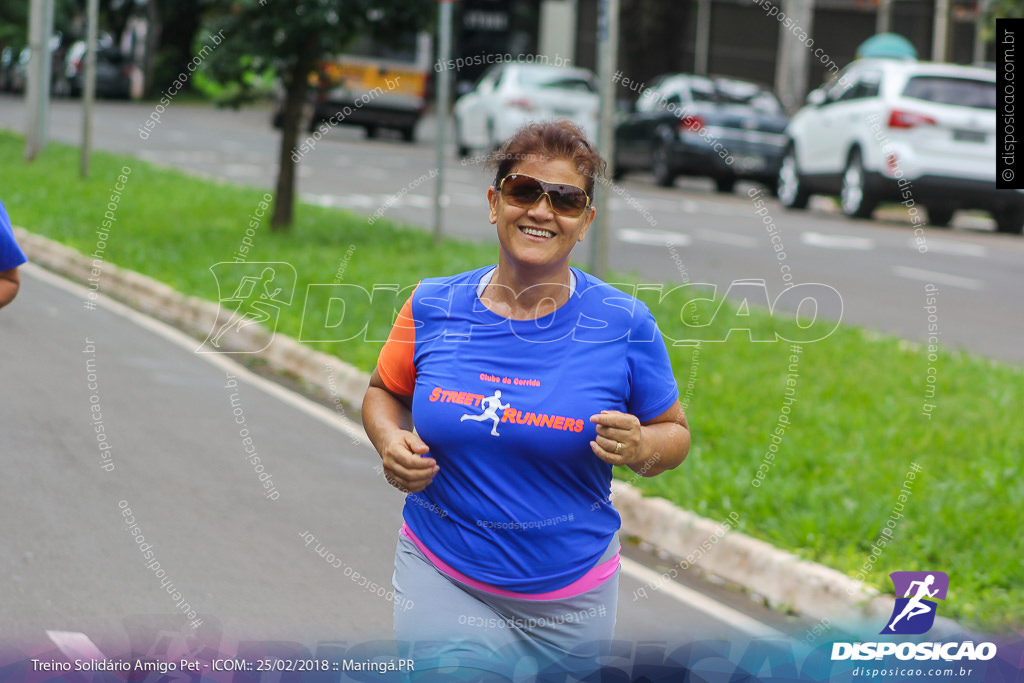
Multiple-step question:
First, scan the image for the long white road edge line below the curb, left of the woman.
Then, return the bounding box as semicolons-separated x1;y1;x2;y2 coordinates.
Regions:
22;263;371;446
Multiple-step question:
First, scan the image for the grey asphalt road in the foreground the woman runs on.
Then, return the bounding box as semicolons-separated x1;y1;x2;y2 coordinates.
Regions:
0;264;800;667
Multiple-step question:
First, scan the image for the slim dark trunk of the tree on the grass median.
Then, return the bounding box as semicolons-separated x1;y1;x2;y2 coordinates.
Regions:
270;36;319;231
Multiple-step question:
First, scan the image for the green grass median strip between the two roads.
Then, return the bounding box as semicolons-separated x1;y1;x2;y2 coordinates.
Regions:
0;131;1024;631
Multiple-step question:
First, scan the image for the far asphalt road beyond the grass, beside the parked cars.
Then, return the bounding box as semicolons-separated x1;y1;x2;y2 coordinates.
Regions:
0;95;1024;364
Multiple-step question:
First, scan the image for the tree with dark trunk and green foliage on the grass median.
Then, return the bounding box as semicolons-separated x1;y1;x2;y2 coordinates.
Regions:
204;0;436;230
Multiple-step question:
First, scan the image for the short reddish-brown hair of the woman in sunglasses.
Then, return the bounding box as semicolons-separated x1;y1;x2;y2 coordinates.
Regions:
488;119;607;202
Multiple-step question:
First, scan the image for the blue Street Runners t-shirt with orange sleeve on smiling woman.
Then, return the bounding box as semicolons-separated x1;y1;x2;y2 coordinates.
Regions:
378;266;679;593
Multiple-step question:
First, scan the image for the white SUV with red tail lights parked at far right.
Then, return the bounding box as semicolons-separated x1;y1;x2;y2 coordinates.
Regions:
778;59;1024;233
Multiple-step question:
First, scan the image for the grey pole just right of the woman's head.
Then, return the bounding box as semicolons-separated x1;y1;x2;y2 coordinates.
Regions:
590;0;618;280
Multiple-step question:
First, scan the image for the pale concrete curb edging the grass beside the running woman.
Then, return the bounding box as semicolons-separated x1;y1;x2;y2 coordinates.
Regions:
14;227;963;638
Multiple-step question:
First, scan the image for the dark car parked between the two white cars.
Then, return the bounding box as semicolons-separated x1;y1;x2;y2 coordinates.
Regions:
613;74;788;193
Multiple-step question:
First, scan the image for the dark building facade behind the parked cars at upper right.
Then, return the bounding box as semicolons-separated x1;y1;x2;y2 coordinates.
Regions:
456;0;993;109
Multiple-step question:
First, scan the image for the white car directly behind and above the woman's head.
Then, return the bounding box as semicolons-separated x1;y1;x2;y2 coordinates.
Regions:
453;61;598;158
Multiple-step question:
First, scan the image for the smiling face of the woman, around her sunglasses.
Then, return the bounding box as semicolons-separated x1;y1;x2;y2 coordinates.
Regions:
487;159;595;270
